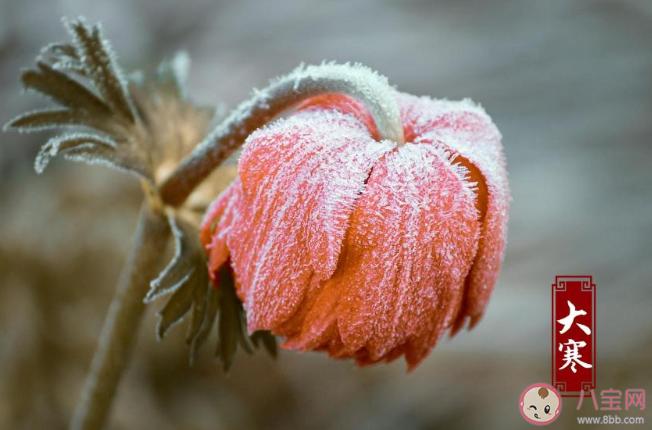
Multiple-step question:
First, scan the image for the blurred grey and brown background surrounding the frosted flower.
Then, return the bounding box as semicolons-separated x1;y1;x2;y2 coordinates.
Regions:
0;0;652;430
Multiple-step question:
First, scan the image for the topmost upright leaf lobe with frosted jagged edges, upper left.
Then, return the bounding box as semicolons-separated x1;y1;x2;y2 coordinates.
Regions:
68;18;136;123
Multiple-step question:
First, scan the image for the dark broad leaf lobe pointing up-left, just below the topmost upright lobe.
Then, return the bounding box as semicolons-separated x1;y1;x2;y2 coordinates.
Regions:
21;61;110;115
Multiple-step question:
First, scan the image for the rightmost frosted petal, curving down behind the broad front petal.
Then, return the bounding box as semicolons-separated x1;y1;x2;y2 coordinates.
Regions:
400;94;510;332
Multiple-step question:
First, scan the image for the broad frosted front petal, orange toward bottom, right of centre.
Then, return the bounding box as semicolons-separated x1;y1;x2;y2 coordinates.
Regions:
286;145;479;367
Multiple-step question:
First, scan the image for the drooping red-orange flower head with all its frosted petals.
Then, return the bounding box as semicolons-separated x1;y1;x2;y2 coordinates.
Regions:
201;94;509;368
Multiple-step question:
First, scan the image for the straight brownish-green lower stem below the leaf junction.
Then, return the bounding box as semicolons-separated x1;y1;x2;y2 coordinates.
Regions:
70;201;169;430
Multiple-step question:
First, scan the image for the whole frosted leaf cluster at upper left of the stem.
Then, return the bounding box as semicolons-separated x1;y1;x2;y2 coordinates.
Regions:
4;18;222;185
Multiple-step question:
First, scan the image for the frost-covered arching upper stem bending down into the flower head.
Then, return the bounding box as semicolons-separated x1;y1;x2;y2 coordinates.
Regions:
160;64;403;206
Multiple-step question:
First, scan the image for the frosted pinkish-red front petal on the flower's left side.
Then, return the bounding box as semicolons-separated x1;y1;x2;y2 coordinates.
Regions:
228;110;392;331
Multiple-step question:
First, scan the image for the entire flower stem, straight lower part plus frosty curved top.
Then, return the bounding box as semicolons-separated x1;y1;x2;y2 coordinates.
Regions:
71;64;404;430
